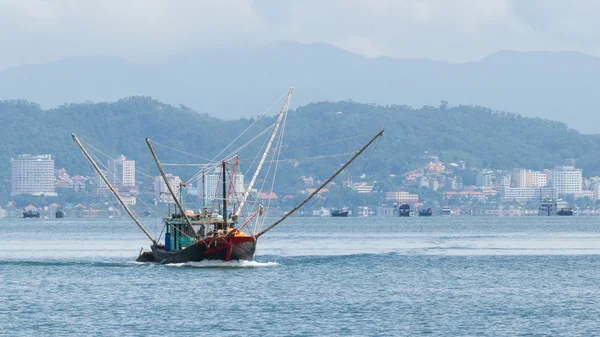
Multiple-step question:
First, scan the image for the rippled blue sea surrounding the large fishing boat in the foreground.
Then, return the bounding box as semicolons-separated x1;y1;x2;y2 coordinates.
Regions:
0;216;600;336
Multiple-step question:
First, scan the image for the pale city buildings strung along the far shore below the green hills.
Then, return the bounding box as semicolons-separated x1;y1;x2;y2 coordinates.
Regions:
11;150;600;215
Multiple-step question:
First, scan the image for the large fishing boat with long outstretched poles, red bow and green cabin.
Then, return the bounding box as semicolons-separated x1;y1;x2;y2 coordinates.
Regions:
72;88;384;264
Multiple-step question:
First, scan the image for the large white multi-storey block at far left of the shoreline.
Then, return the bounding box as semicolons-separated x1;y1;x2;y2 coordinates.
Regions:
10;154;56;196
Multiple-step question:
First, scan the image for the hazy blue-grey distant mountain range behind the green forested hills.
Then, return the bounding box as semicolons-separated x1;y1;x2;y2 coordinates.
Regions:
0;42;600;137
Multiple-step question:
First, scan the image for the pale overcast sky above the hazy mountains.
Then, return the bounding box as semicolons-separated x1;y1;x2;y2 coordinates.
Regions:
0;0;600;70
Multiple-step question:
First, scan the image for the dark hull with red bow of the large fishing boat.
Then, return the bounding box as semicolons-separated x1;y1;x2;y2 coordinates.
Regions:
136;236;256;264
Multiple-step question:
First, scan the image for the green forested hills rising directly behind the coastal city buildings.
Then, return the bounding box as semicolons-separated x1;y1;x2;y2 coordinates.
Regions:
0;97;600;194
